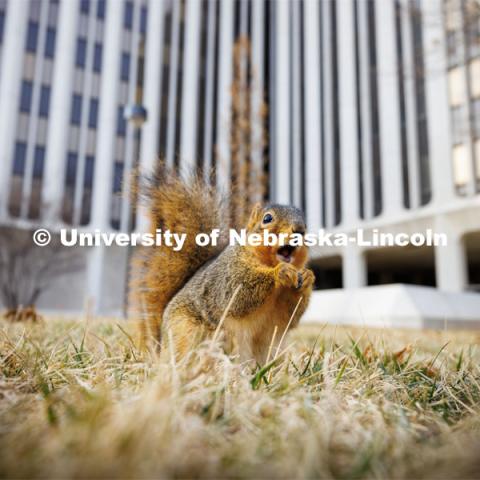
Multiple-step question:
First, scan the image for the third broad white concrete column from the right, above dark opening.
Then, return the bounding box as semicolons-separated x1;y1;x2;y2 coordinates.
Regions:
337;0;359;227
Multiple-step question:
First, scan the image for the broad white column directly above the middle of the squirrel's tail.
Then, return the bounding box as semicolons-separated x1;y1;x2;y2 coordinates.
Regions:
180;0;204;169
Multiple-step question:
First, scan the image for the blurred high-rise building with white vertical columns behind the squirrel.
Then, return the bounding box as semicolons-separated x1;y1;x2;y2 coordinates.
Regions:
0;0;480;325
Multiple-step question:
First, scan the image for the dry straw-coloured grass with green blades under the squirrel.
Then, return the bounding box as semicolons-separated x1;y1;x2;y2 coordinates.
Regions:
0;319;480;478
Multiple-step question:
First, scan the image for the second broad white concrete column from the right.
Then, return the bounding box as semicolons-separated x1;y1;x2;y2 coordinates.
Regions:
375;0;403;216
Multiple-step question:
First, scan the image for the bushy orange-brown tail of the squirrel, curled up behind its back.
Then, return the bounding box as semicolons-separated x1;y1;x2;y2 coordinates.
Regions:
136;164;228;343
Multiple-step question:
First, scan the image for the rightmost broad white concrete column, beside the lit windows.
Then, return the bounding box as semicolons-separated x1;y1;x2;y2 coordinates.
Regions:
420;0;455;205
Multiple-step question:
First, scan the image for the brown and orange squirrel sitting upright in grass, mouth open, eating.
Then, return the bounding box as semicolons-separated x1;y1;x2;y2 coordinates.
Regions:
141;166;315;364
